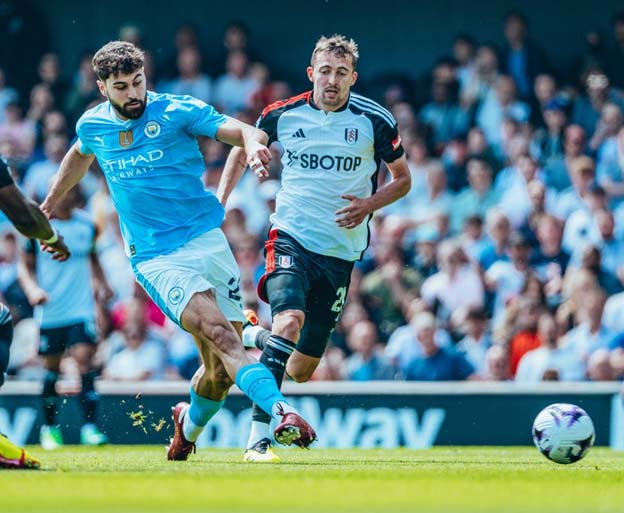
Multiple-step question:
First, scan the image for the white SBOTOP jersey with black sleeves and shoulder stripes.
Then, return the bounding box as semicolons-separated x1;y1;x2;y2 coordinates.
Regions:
256;91;404;261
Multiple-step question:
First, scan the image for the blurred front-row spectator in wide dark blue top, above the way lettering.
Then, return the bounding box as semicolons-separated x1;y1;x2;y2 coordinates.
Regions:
403;313;477;381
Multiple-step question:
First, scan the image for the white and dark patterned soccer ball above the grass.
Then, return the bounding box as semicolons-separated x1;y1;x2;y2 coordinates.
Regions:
533;403;595;464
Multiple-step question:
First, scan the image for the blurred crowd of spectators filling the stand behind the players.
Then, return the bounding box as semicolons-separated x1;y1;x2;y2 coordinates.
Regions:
0;12;624;383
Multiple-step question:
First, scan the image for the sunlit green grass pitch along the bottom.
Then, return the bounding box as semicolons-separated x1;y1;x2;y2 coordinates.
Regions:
0;446;624;513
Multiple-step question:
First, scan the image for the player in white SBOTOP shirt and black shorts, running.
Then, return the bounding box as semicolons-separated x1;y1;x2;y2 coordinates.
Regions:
217;35;410;462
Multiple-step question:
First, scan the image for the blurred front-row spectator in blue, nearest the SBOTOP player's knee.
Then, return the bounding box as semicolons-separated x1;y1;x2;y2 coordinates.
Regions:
342;320;396;381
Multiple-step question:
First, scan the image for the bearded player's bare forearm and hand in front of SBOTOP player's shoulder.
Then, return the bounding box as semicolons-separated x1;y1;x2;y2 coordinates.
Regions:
217;118;271;176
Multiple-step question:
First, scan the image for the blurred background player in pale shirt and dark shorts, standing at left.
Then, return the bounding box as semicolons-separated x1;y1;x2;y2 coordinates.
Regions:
18;187;113;450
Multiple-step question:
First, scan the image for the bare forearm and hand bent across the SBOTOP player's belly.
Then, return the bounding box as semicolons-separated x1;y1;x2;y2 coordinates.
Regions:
336;155;412;229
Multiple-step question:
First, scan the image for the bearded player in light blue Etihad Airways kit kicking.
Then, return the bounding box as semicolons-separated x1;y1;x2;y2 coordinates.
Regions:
42;41;316;460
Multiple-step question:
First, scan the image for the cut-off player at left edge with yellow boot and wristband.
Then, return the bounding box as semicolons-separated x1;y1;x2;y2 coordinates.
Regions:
0;158;70;469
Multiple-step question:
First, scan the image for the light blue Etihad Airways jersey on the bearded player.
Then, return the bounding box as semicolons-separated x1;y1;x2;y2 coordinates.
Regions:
76;91;228;265
